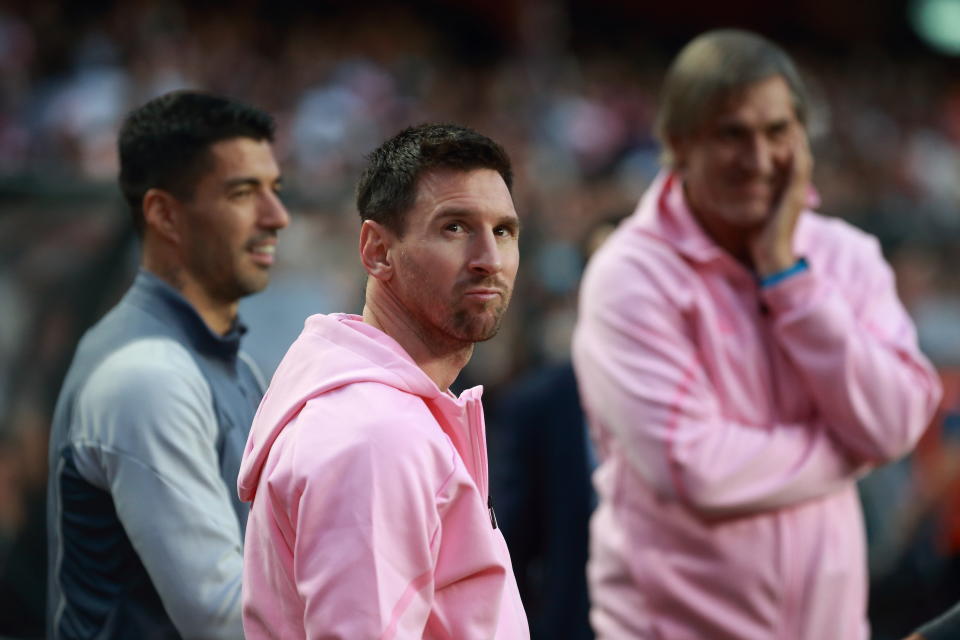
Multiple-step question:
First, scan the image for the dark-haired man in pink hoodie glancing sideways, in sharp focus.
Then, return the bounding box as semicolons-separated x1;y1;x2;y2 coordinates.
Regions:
238;125;529;640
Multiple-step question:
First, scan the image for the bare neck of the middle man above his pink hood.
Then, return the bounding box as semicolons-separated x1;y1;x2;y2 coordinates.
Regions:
363;280;473;391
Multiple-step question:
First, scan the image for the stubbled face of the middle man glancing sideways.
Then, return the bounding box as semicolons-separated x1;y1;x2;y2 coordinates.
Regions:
391;169;520;344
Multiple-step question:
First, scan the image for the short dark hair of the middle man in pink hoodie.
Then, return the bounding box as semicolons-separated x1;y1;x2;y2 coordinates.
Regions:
357;124;513;235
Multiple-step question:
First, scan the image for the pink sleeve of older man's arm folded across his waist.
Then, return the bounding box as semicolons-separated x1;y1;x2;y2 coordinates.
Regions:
573;240;857;515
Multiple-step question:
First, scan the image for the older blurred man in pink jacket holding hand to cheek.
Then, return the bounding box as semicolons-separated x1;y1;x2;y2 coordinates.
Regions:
573;30;940;640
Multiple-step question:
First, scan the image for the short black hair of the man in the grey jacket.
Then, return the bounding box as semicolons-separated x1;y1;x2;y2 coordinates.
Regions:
118;91;275;236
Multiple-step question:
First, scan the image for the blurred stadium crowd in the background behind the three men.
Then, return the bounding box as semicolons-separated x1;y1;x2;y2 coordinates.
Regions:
0;0;960;637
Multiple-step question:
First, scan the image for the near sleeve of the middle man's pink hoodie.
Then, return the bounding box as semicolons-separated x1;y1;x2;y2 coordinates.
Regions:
288;403;452;640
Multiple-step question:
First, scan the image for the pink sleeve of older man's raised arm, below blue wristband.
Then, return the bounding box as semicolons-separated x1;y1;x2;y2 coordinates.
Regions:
763;232;941;464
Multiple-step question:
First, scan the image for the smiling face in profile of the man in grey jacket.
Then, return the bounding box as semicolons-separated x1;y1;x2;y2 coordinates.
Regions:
181;138;290;302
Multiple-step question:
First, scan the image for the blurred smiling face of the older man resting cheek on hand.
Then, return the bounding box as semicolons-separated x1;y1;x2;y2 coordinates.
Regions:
673;76;805;231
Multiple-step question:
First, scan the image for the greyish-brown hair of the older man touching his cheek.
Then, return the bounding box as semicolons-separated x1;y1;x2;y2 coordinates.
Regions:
654;29;808;165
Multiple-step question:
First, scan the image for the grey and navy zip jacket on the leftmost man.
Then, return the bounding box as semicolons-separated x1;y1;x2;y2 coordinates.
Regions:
48;271;263;638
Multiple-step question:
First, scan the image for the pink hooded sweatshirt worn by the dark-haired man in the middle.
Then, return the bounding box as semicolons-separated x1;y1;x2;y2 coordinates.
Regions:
238;314;529;640
